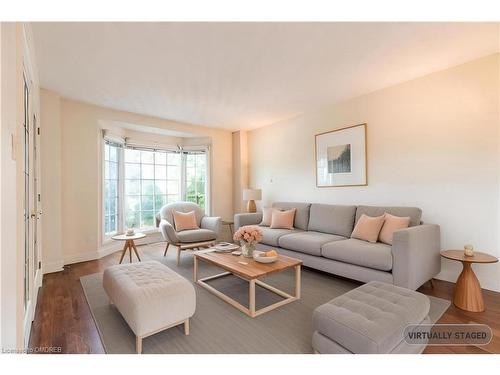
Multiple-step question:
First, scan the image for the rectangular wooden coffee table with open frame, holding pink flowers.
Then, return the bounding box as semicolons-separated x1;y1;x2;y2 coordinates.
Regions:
194;251;302;318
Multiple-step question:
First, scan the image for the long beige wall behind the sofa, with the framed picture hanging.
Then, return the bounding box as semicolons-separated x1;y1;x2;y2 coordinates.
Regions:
249;55;500;290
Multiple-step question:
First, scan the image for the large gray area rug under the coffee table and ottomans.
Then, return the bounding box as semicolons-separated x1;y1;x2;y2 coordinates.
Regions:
80;244;450;354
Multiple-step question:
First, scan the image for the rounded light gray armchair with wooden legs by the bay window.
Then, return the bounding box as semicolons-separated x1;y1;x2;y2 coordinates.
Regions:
159;202;221;265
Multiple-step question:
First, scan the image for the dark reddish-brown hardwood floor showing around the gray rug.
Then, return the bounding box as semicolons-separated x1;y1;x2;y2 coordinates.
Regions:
30;248;500;354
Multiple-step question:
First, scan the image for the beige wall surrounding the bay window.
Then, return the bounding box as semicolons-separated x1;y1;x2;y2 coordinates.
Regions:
41;90;233;272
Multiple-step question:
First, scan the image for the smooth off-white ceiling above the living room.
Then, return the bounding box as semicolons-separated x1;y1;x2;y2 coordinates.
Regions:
32;23;499;130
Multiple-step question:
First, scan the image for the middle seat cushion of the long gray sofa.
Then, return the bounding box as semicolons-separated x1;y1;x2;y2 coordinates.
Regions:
278;231;346;256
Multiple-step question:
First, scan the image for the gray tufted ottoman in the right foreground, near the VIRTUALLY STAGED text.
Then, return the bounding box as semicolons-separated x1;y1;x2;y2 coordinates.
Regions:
312;281;430;354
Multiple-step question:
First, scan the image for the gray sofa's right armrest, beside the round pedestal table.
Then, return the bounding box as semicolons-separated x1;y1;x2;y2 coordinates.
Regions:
392;224;441;290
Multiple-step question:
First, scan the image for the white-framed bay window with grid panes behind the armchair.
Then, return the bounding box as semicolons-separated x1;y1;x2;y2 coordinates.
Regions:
103;140;209;237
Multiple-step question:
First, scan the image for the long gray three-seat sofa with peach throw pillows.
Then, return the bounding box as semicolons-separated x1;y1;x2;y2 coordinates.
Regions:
234;202;441;290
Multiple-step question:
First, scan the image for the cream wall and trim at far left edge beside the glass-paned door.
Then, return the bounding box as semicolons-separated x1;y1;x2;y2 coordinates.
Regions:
0;22;41;349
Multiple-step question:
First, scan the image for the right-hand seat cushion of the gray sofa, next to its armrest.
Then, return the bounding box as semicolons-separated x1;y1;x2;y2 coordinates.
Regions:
321;238;392;271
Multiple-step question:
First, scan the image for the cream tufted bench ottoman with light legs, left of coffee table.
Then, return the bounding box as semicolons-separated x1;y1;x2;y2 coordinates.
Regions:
103;261;196;353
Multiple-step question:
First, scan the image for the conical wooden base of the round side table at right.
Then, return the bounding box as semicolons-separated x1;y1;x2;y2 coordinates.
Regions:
453;262;485;312
